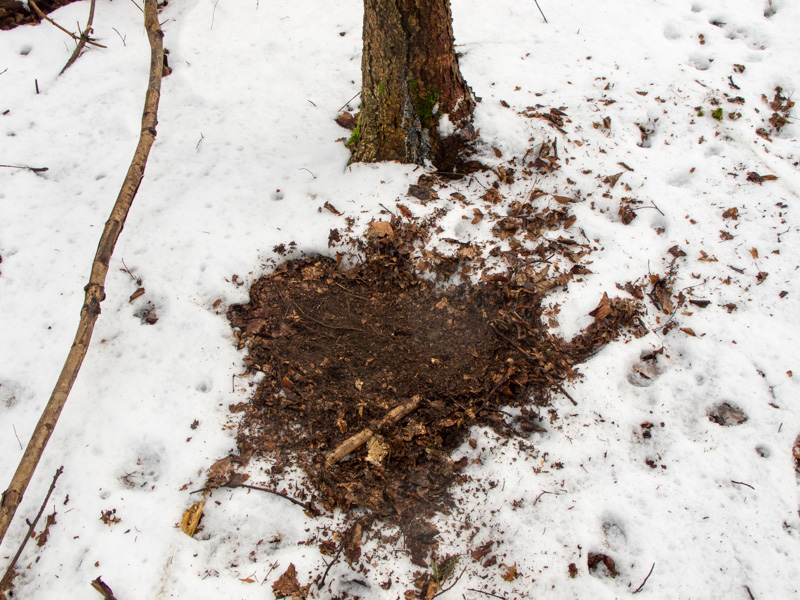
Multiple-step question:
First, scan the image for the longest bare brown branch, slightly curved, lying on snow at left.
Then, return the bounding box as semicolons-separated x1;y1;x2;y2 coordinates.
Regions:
0;0;164;543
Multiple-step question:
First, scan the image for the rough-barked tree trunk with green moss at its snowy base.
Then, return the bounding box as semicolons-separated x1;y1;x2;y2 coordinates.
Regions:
348;0;475;170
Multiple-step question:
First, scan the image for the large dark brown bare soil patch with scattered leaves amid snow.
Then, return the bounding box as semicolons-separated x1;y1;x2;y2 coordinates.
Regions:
228;224;636;564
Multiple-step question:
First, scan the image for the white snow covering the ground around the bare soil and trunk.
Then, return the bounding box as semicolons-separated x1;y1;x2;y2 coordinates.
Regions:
0;0;800;599
